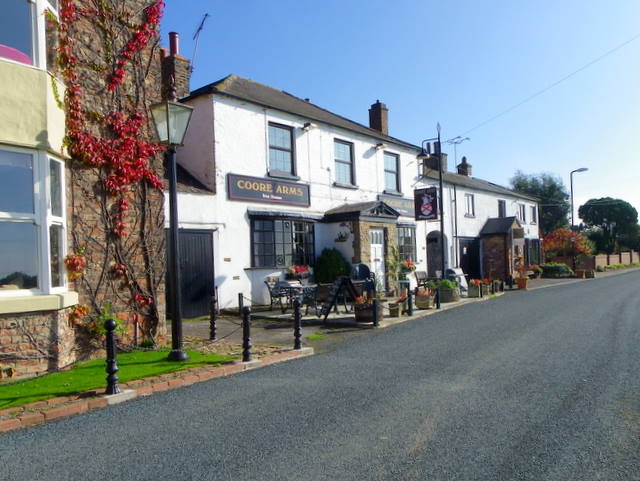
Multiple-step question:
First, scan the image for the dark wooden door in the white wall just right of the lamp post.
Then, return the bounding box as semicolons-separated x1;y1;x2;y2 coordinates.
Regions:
167;229;215;319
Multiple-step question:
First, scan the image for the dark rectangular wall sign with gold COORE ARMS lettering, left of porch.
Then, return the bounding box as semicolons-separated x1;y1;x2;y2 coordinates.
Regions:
227;174;310;207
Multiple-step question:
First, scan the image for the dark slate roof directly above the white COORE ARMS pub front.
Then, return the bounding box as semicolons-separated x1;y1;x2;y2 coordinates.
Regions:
182;75;420;150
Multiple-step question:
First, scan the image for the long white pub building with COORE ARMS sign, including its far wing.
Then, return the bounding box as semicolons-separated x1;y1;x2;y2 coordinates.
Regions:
171;75;539;310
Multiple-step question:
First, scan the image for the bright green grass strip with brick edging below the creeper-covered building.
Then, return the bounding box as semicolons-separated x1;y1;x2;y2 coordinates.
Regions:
0;351;237;409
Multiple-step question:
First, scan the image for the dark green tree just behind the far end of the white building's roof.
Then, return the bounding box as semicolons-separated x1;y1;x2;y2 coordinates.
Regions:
511;170;571;235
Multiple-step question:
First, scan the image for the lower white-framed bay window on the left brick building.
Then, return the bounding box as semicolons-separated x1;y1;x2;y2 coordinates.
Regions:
0;148;66;295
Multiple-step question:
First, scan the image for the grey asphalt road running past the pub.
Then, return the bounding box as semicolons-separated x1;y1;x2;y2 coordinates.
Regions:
0;272;640;481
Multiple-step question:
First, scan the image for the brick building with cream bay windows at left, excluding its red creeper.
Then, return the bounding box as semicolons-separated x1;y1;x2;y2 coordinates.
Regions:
0;0;167;377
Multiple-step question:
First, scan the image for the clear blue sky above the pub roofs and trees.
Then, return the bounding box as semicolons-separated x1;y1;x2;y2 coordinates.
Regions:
161;0;640;221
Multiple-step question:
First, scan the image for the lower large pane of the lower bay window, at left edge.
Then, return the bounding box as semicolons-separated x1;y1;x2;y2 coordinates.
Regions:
0;222;38;289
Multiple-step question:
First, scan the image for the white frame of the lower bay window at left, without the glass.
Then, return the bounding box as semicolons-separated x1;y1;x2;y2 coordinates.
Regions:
0;145;68;298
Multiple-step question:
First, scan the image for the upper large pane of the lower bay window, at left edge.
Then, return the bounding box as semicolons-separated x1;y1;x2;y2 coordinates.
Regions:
0;150;33;214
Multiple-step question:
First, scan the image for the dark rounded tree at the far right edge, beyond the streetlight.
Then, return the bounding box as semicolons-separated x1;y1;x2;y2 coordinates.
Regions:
578;197;638;254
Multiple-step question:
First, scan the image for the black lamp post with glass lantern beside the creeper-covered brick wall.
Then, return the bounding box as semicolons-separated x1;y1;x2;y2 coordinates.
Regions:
151;96;193;361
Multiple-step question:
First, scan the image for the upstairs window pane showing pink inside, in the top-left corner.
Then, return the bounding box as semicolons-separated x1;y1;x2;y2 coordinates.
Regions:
0;0;33;65
